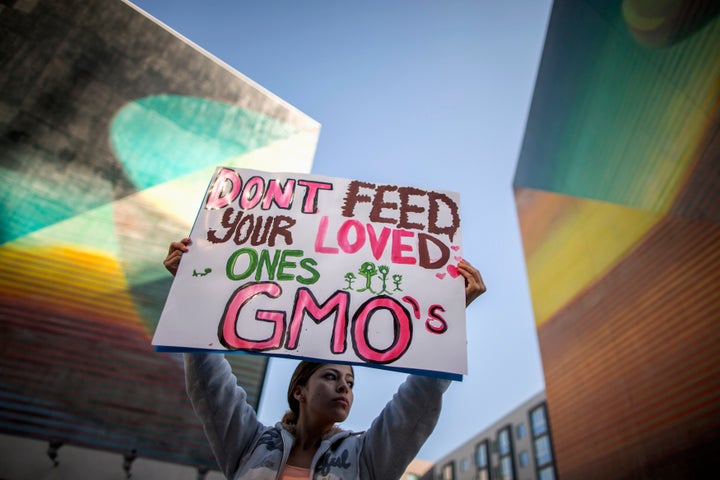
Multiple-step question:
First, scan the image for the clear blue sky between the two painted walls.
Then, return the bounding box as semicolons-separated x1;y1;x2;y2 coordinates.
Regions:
133;0;552;461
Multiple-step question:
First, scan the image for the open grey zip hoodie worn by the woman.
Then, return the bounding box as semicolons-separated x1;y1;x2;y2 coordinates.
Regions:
184;353;450;480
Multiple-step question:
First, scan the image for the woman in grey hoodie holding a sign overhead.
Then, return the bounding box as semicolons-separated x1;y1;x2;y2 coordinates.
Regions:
164;238;485;480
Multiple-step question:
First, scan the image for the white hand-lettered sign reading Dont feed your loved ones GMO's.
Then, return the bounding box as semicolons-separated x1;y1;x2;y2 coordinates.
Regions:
153;167;467;379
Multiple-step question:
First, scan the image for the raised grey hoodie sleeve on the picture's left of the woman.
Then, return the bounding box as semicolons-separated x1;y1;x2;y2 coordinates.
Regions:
183;353;263;478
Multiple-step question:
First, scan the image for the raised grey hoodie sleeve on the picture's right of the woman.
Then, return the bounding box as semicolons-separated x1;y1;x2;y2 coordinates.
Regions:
360;375;450;480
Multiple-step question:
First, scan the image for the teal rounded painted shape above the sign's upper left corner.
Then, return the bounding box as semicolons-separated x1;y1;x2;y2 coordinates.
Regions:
110;95;297;190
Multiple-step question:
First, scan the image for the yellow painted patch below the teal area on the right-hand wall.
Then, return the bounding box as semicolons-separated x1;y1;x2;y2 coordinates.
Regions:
527;197;662;326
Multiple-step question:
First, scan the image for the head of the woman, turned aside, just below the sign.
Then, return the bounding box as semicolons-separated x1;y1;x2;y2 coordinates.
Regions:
296;364;355;424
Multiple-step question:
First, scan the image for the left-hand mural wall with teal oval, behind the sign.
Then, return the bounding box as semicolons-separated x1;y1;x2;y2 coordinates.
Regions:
0;0;320;468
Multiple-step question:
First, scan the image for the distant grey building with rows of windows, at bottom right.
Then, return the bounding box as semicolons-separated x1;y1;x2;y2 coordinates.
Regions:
421;392;557;480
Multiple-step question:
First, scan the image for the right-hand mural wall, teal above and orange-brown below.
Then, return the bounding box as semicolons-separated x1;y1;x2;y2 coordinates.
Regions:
514;0;720;480
